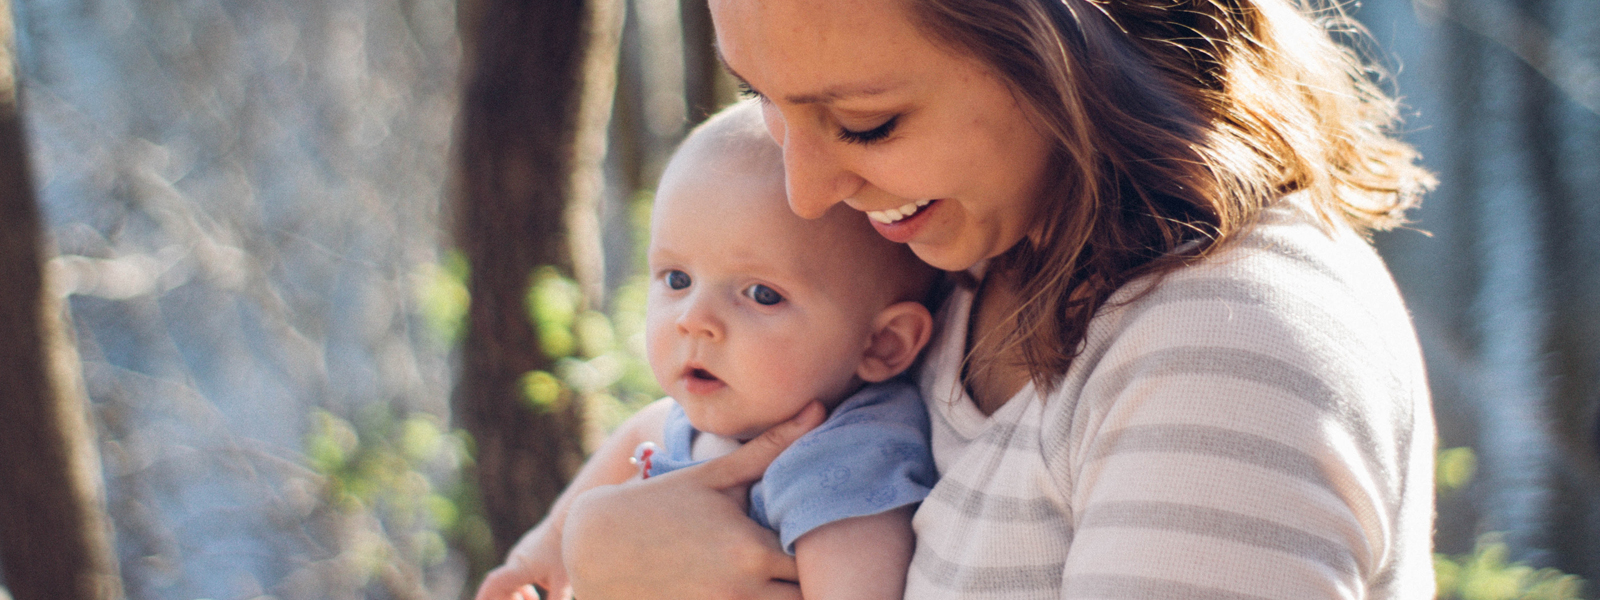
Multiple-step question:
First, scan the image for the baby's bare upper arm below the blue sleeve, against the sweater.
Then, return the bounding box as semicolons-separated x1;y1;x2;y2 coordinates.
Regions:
795;504;917;600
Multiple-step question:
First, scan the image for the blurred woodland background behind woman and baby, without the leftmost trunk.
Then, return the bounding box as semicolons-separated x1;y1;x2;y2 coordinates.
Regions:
0;0;1600;600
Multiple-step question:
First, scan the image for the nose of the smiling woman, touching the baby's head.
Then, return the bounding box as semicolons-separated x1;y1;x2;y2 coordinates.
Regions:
766;109;864;219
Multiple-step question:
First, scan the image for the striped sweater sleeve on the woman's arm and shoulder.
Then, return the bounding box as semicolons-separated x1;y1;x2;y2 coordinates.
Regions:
1040;224;1432;598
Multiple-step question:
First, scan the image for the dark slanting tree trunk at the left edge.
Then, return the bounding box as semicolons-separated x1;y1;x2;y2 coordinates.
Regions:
0;2;122;600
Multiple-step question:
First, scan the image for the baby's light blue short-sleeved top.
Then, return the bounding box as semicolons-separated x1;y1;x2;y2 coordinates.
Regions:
650;378;939;554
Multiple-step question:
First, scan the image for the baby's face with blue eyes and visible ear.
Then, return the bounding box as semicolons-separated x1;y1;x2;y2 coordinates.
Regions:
646;162;888;440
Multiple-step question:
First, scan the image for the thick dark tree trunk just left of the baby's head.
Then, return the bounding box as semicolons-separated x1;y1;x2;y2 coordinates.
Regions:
453;0;622;569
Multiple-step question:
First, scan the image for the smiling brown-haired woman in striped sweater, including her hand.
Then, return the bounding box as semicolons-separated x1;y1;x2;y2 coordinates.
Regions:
537;0;1434;600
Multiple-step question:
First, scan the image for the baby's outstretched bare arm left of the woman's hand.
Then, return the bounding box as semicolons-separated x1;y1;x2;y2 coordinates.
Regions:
477;398;672;600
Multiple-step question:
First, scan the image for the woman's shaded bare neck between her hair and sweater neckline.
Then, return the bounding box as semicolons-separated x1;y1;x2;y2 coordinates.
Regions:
965;269;1029;414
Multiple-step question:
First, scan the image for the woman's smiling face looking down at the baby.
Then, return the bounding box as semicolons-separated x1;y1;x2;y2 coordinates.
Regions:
710;0;1050;270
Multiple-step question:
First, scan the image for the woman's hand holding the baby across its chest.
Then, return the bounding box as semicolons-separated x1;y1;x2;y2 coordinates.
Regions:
562;403;826;600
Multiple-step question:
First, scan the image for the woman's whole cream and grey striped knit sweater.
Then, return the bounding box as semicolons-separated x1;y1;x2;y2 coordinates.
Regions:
906;202;1434;600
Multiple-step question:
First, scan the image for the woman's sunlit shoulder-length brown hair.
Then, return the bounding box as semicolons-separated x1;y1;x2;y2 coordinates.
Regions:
907;0;1434;390
